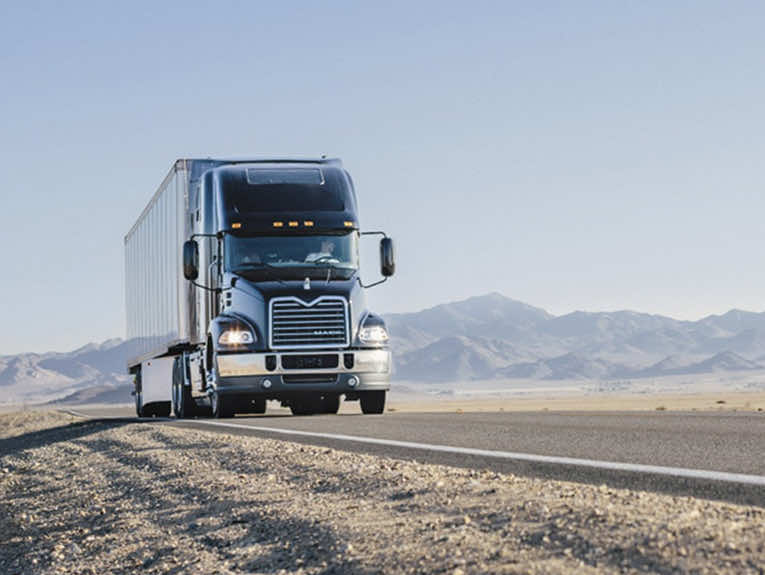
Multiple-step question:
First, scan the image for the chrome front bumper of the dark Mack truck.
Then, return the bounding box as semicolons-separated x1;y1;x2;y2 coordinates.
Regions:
217;349;391;397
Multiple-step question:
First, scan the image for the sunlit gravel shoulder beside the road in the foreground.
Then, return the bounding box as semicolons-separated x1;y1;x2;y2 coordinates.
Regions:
0;412;765;575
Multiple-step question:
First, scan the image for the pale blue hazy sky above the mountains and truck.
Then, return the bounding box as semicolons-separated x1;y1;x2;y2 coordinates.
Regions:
0;1;765;355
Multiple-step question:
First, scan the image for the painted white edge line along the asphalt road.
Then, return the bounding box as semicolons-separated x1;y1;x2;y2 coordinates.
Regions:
62;410;765;487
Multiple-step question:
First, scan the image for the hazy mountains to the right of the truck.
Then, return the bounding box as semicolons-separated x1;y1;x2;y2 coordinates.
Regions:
386;293;765;382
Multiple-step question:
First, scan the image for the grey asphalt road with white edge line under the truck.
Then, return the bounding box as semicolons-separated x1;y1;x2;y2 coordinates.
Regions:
68;408;765;507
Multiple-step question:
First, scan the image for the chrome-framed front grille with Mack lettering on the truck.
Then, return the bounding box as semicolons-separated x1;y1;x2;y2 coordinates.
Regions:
269;296;349;349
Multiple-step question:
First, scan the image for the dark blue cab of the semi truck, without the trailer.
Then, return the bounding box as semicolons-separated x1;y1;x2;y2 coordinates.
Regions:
179;159;395;417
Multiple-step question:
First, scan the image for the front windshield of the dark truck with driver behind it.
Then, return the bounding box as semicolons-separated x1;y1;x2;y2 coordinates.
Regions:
223;232;359;281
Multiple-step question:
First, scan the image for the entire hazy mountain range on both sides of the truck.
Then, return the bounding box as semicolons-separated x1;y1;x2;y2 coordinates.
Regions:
0;293;765;403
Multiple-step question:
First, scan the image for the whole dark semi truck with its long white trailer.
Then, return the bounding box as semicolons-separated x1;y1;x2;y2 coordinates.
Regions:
125;158;395;418
